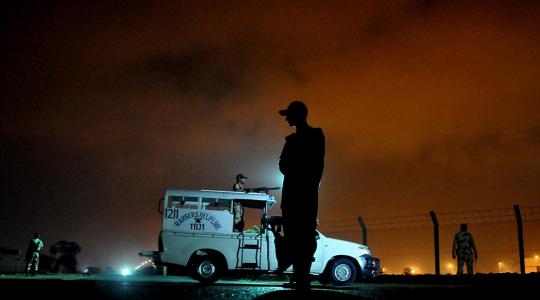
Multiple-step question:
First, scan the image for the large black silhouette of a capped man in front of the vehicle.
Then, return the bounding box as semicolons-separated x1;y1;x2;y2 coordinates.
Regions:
279;101;325;290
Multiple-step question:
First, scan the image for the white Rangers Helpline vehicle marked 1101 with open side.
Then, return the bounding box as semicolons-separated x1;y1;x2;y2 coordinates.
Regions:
140;189;379;285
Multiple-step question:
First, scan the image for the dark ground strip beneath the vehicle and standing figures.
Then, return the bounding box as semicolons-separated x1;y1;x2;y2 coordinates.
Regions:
0;274;540;300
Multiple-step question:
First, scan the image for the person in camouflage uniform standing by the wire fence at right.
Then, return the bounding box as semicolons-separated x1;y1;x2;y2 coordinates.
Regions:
452;224;478;275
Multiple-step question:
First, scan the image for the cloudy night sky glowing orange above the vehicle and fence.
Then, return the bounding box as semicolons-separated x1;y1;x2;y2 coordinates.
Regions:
0;0;540;272
